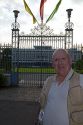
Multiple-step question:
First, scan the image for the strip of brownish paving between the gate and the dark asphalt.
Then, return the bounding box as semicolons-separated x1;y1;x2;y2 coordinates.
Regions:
0;87;41;101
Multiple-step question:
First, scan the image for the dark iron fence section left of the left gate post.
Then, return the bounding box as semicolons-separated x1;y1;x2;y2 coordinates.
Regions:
0;44;12;73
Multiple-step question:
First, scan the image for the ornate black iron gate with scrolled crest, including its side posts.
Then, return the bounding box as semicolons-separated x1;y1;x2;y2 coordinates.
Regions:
12;9;73;87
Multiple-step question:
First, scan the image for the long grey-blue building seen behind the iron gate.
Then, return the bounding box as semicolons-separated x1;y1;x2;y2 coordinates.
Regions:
12;46;82;67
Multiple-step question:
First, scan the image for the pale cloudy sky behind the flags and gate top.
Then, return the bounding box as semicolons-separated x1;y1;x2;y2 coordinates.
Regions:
0;0;83;44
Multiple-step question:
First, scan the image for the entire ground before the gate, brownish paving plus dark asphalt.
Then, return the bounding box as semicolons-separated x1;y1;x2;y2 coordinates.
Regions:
0;87;41;125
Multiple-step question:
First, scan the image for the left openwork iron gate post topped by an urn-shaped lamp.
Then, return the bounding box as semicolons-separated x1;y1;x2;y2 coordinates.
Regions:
11;10;20;86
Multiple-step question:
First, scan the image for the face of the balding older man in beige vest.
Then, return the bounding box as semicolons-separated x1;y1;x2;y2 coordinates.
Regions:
53;51;71;76
